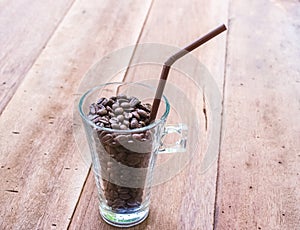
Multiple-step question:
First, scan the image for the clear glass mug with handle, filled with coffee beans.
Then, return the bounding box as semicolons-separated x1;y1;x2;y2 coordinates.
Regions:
79;82;187;227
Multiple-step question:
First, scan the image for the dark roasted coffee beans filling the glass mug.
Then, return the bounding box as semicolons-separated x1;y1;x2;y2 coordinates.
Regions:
88;95;153;212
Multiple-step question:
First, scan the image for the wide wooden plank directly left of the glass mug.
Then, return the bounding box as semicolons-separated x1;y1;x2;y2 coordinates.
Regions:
0;0;154;229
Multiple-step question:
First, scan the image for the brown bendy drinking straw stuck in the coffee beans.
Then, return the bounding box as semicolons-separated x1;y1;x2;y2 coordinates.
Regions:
150;25;226;121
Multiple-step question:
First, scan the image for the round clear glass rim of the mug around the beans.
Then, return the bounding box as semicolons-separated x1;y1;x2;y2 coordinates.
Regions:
78;82;170;134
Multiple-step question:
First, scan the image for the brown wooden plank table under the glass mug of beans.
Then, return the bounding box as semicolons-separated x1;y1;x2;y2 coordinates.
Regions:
0;0;300;230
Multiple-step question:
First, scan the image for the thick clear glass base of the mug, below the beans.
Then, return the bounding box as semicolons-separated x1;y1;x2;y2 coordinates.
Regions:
100;207;149;228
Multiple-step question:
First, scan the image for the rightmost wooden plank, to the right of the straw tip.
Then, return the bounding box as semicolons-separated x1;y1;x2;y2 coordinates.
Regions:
216;0;300;229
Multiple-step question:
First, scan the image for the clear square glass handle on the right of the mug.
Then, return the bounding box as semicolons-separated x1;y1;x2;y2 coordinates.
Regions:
158;124;188;154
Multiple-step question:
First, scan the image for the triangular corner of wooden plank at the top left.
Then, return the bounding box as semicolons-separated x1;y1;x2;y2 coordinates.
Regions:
0;0;74;114
